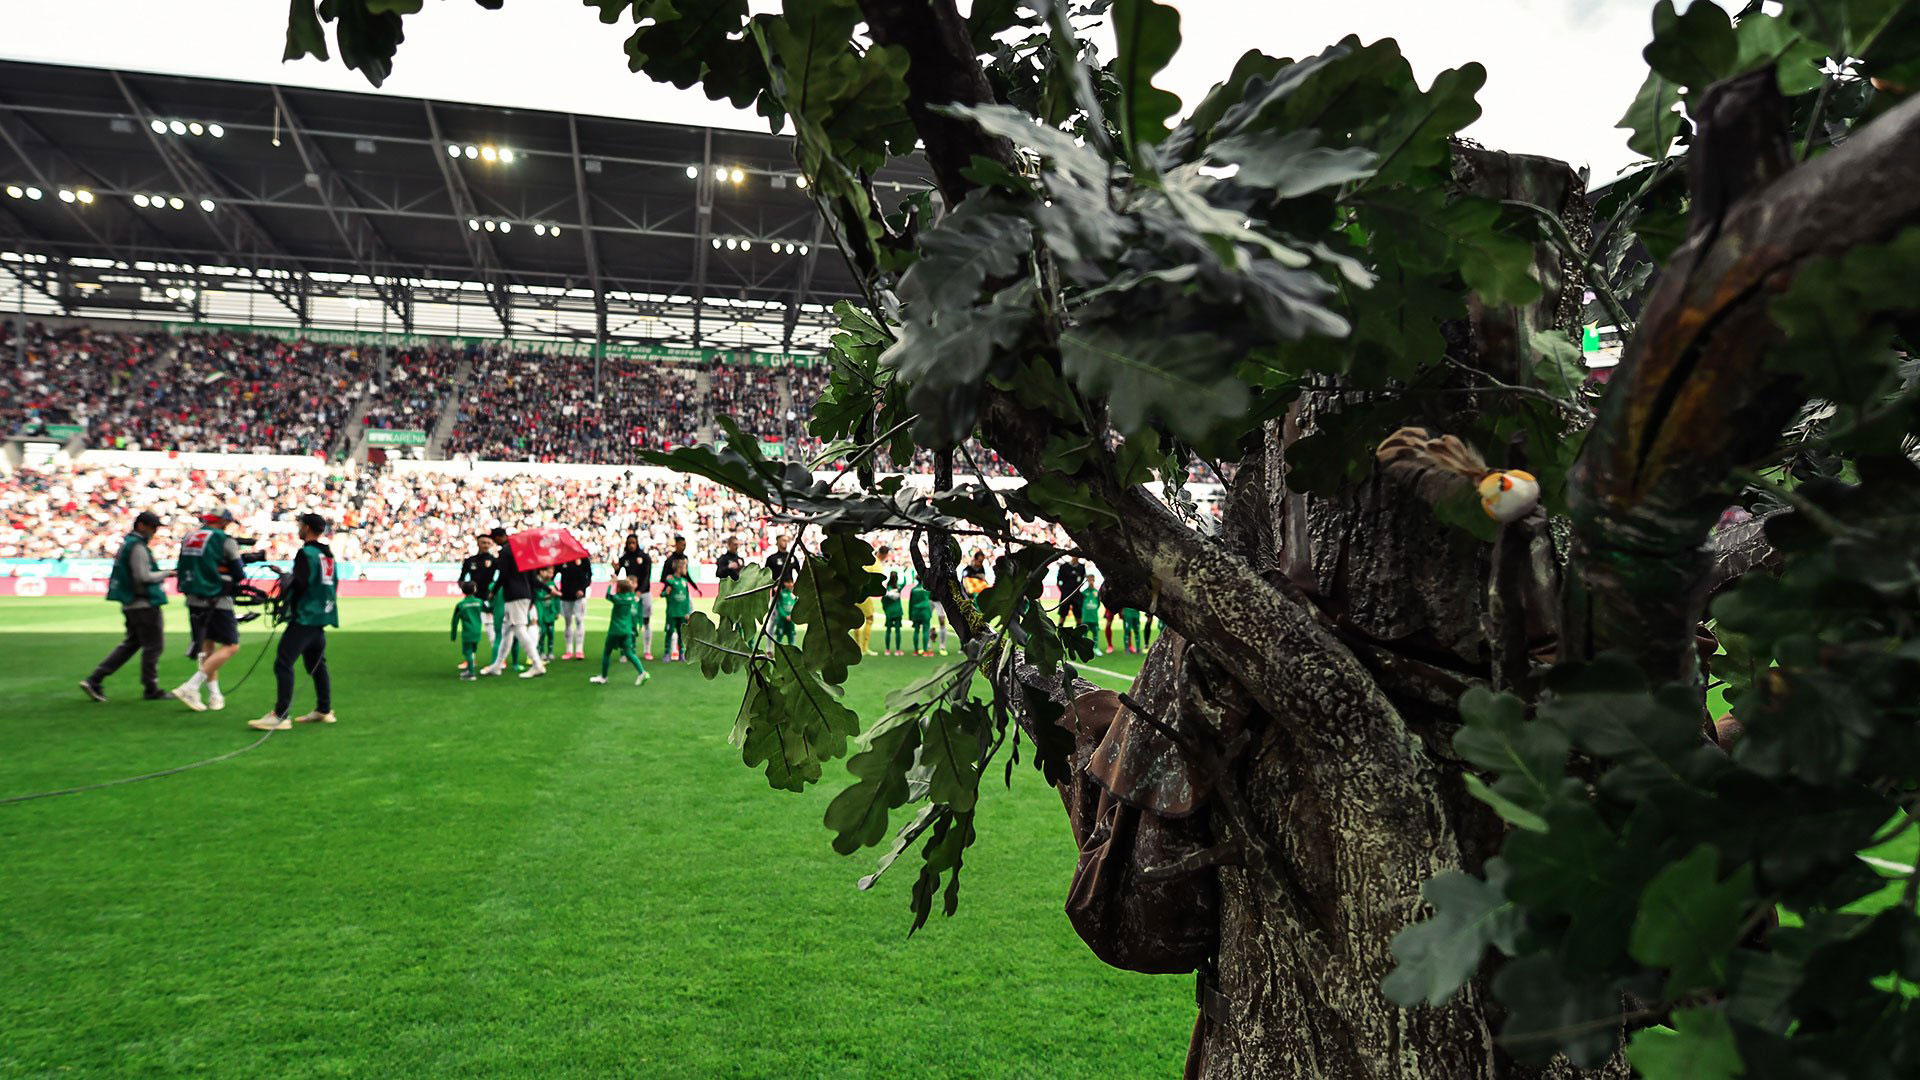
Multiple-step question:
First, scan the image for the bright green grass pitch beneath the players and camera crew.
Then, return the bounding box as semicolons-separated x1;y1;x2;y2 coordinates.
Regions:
0;600;1192;1078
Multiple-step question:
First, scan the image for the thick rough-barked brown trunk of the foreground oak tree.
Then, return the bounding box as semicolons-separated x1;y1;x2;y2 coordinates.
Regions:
1156;150;1628;1080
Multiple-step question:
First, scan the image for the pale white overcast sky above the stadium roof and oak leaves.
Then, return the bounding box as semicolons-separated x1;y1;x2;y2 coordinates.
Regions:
0;0;1681;181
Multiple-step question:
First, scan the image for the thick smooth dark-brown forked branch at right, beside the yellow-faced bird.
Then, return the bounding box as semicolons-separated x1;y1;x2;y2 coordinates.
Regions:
1561;71;1920;680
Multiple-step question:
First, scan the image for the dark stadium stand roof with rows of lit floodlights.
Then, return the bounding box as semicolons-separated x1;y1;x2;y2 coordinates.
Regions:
0;61;925;352
